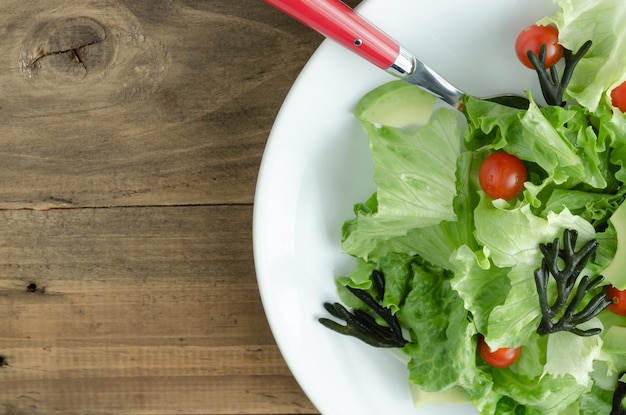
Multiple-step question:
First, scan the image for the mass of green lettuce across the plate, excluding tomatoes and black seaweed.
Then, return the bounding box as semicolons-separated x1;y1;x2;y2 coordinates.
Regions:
322;0;626;415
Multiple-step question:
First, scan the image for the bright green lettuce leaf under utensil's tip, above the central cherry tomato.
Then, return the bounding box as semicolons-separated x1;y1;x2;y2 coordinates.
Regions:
465;96;623;189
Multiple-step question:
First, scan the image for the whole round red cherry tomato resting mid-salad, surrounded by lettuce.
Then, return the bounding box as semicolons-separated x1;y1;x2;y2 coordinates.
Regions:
478;151;526;200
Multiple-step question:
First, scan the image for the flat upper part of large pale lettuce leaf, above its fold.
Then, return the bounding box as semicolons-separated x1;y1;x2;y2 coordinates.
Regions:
363;109;461;224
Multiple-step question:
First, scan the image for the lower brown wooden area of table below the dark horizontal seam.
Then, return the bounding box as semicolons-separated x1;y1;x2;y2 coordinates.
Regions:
0;206;315;415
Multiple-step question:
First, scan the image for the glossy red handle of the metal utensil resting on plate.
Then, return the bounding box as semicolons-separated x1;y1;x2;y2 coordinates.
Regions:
265;0;400;69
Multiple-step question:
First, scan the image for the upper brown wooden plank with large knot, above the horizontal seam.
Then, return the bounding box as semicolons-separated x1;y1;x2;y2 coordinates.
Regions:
0;0;321;208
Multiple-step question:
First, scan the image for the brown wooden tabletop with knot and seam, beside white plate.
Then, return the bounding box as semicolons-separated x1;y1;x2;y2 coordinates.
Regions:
0;0;358;415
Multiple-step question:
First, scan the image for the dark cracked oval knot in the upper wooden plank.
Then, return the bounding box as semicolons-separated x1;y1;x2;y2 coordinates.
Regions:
21;16;113;81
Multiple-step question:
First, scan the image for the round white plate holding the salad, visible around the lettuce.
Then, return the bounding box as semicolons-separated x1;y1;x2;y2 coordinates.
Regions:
253;0;555;415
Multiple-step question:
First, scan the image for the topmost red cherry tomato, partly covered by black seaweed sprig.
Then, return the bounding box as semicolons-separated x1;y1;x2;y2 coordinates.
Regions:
515;25;563;69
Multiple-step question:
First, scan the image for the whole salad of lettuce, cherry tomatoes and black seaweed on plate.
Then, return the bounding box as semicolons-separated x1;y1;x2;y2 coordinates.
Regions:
320;0;626;414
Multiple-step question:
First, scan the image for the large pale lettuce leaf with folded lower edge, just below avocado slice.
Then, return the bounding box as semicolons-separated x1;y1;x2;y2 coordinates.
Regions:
342;109;462;267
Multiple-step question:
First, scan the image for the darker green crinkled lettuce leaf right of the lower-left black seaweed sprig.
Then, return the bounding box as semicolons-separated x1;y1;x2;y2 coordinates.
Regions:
397;266;500;413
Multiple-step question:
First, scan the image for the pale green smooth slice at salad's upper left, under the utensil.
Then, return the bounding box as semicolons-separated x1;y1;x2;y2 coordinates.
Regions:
354;80;437;128
